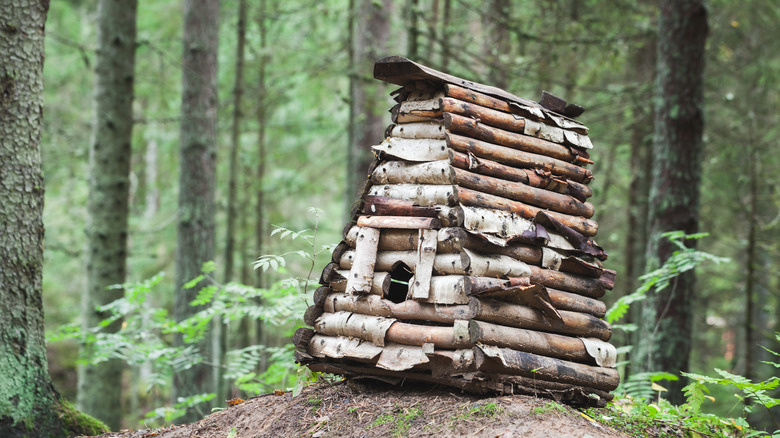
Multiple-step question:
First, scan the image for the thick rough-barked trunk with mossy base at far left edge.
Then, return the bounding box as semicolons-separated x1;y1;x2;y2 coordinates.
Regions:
0;0;99;438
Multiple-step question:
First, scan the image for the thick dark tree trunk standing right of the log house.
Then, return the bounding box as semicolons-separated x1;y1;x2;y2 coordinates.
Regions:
634;0;707;403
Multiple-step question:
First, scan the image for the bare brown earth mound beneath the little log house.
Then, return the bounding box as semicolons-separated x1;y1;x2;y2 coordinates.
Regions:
90;380;683;438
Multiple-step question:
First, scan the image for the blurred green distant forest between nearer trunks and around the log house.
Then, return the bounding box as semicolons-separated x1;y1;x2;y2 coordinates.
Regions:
29;0;780;432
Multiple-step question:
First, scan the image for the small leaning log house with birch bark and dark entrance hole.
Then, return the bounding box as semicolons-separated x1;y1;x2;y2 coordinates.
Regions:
294;57;619;406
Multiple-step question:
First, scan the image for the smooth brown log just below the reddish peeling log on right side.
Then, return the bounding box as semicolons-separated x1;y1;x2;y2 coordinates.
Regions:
454;168;593;218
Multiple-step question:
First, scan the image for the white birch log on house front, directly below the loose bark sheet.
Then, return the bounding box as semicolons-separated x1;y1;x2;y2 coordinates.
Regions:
371;160;455;185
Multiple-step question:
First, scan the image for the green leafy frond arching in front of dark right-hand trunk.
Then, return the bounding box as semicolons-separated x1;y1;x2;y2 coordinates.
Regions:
604;231;729;331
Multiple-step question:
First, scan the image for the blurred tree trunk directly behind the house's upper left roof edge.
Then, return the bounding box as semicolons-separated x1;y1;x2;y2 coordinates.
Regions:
347;0;392;210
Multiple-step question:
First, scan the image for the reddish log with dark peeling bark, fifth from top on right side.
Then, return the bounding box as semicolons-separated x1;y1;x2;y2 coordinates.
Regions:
452;151;593;202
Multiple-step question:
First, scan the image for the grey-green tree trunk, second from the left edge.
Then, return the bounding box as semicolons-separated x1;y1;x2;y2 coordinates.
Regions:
78;0;137;430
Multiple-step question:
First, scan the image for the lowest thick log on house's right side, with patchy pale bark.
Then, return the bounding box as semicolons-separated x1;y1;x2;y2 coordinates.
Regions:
474;346;620;391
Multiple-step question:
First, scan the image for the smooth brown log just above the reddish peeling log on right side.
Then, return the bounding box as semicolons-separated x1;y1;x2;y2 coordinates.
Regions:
444;133;593;183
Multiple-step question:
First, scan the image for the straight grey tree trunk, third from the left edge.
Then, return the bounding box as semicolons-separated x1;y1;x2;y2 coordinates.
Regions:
172;0;219;423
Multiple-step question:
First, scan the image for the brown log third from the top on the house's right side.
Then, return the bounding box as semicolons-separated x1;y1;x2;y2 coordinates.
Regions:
442;113;578;163
